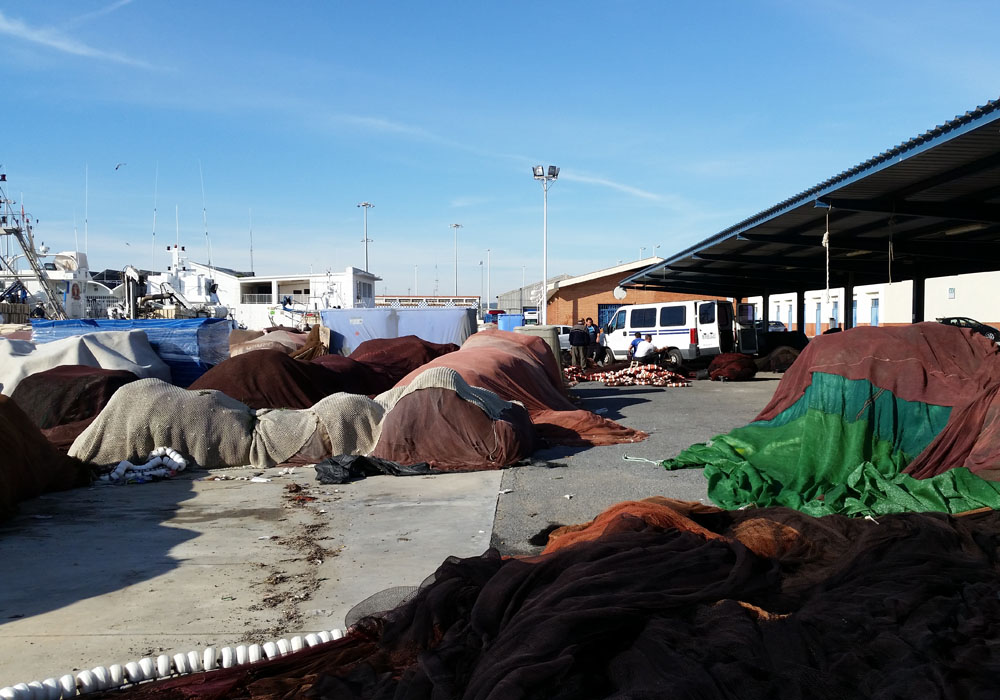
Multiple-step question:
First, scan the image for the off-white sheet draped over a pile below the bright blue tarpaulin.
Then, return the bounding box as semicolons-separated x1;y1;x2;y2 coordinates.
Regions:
0;331;170;396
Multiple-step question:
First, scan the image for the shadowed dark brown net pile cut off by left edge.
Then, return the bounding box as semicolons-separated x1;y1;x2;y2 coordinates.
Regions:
0;395;89;519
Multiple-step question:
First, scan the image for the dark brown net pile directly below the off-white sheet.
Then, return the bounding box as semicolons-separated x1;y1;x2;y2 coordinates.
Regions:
11;365;138;452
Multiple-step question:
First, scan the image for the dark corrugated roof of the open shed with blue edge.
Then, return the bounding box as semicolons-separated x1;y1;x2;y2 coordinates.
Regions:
621;100;1000;297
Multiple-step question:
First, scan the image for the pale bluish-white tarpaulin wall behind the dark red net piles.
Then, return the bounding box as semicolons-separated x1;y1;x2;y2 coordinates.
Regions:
320;307;476;355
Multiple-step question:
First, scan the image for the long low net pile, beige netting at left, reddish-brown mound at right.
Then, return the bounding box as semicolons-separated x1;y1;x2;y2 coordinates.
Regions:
70;368;534;471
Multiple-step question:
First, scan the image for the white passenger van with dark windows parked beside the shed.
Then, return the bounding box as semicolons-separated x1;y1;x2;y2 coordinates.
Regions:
601;299;735;364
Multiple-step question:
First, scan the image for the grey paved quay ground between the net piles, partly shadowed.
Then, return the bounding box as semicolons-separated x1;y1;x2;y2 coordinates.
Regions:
0;375;779;687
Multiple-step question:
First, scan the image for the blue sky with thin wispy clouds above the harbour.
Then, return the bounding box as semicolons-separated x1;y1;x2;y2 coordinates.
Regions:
0;0;1000;295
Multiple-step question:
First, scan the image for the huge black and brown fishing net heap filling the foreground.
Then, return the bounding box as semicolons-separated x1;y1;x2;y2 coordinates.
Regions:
99;499;1000;700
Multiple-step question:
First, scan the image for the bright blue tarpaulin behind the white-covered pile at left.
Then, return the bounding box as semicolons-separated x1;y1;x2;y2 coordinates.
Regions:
31;318;232;386
